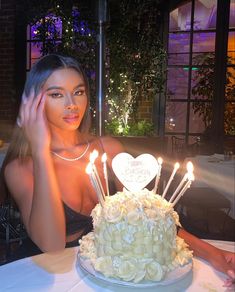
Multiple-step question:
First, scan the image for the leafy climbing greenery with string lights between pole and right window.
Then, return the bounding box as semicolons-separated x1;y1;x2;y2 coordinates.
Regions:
106;0;166;134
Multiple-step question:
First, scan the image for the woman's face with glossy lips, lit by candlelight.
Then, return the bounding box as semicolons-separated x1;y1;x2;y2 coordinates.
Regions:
42;68;88;130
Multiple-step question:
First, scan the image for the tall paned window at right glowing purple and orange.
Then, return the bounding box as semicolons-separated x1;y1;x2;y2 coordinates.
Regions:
165;0;217;144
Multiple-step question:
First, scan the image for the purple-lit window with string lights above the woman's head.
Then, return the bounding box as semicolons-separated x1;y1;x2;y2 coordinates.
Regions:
26;5;95;74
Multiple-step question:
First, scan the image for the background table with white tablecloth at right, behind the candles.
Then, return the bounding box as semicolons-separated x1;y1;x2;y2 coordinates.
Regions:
184;154;235;219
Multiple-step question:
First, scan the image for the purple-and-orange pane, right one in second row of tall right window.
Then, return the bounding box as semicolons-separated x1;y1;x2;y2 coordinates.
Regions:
193;32;215;53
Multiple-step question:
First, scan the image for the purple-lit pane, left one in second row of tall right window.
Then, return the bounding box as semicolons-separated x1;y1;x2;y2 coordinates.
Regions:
168;33;190;53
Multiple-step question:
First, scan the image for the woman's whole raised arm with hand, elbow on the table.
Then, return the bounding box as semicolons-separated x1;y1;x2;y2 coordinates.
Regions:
5;95;66;251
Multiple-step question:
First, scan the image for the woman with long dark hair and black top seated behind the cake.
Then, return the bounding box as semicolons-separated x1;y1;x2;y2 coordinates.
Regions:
0;55;234;286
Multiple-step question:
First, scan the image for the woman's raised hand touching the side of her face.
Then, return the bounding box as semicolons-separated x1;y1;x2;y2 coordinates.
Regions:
18;92;51;153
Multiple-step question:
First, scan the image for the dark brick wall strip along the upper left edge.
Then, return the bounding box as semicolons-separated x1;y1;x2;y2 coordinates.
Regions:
0;0;16;140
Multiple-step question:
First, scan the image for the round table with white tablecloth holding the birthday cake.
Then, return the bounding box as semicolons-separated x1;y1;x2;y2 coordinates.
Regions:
0;240;234;292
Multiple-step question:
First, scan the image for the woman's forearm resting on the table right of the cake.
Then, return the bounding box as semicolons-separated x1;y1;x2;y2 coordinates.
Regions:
178;229;235;279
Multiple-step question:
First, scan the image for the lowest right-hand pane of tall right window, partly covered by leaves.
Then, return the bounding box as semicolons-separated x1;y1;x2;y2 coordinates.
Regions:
189;101;207;134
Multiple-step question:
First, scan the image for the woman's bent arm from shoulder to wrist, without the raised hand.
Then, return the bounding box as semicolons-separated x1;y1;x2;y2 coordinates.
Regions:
5;153;65;252
